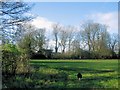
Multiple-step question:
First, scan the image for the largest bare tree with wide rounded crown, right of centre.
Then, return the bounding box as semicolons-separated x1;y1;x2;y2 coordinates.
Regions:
81;22;109;56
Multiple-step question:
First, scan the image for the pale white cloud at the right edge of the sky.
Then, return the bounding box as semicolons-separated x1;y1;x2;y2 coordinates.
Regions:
88;12;118;33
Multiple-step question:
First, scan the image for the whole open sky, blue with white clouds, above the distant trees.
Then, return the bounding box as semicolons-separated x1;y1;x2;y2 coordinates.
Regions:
28;2;118;33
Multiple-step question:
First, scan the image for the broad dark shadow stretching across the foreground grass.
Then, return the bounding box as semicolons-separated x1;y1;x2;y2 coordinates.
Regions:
3;65;118;90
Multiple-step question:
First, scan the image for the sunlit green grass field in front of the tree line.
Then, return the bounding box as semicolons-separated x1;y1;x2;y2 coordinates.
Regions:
28;60;119;88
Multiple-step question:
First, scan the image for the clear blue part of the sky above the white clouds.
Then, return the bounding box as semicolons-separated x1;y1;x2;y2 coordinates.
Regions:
32;2;118;24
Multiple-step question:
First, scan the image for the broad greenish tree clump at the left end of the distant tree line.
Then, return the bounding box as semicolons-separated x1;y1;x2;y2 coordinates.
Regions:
17;24;46;56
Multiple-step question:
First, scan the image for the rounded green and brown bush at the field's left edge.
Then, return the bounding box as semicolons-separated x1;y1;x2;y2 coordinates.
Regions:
2;44;28;76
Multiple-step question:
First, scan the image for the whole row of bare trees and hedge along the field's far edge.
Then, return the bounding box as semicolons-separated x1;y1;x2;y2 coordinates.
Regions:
15;21;120;59
